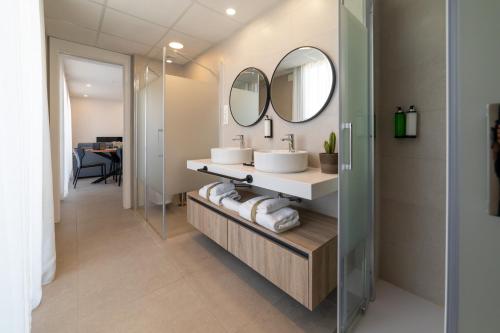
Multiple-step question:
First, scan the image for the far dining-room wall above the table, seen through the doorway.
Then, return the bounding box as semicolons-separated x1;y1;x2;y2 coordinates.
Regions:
71;97;123;147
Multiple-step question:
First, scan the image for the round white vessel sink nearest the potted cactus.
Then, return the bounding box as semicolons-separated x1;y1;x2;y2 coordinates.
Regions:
254;150;308;173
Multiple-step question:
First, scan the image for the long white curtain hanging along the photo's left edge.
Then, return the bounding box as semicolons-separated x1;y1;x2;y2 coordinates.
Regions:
0;0;55;333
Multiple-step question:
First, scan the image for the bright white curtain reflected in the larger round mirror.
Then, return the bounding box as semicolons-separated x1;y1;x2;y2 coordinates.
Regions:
293;59;332;121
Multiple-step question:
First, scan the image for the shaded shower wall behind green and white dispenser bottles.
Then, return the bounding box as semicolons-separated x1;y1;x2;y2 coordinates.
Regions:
375;0;446;304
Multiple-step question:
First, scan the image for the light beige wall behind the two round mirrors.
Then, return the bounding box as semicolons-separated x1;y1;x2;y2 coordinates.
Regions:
186;0;339;166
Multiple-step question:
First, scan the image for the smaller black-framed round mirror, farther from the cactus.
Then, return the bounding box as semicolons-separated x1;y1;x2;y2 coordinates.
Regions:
229;67;269;126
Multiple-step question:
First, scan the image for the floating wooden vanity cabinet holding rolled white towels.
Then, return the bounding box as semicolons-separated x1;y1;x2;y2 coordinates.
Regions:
187;192;337;310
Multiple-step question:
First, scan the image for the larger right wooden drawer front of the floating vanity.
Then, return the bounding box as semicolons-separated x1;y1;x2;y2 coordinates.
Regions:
228;221;309;307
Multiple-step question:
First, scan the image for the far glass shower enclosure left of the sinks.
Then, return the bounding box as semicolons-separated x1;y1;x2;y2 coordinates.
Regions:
134;48;219;239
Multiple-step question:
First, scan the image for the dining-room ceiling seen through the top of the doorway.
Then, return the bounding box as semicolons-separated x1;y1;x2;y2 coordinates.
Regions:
63;56;123;101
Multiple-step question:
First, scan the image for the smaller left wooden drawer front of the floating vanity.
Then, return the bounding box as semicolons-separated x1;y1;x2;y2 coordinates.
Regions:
187;199;228;250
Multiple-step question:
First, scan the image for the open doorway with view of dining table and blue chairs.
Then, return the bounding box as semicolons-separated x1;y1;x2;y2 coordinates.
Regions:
61;56;124;198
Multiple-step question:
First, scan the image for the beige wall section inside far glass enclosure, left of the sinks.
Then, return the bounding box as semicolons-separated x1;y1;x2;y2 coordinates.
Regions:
165;75;219;195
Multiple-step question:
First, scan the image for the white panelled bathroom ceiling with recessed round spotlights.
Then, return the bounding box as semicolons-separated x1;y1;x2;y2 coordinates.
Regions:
45;0;285;64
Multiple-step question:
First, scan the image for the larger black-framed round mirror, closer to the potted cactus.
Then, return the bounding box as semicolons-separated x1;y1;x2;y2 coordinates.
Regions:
271;47;336;123
